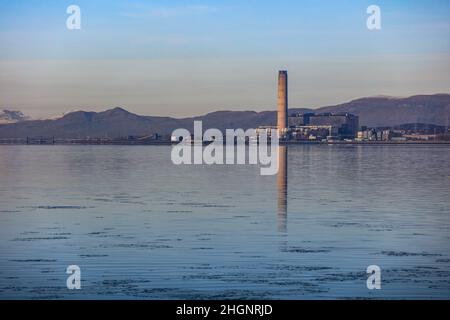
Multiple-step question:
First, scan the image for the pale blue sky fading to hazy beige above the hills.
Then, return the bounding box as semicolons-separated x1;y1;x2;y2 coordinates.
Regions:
0;0;450;118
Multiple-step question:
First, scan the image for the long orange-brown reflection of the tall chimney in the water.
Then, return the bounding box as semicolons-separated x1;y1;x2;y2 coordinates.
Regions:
277;145;287;232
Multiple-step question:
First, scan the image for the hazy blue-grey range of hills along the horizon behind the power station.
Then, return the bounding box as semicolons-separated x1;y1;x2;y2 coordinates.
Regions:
0;94;450;138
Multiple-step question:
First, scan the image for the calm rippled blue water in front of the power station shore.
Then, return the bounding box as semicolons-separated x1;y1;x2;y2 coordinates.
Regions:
0;146;450;299
